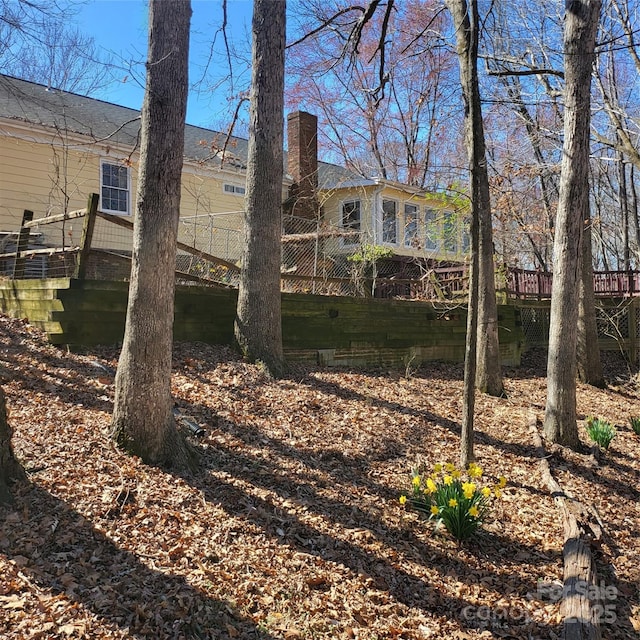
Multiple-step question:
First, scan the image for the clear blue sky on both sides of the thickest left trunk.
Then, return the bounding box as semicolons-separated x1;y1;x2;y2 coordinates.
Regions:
76;0;253;128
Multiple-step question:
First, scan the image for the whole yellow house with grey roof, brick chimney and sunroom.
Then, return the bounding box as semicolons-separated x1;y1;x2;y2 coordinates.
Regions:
0;75;467;277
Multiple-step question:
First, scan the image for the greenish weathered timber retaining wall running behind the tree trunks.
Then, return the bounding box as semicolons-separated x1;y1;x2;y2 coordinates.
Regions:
0;278;524;367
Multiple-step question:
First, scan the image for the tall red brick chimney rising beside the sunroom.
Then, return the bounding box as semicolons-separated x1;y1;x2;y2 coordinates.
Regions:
285;111;318;219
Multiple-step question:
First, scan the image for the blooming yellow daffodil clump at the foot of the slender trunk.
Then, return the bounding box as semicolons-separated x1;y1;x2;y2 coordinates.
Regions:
400;462;507;540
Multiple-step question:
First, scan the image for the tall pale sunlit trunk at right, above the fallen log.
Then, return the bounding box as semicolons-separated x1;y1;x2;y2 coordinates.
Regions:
544;0;601;447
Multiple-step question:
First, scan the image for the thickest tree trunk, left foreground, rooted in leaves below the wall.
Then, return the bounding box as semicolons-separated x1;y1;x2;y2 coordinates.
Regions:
113;0;196;466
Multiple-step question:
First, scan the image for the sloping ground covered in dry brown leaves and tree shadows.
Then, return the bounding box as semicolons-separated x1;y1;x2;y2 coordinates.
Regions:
0;317;640;640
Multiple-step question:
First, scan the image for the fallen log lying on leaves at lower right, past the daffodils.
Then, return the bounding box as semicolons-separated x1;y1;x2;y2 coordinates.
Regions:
529;416;604;640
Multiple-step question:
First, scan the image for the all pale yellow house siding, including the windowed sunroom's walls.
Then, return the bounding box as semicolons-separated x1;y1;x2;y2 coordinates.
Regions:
0;125;463;262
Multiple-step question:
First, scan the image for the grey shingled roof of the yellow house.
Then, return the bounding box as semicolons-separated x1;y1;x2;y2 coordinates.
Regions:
0;74;359;188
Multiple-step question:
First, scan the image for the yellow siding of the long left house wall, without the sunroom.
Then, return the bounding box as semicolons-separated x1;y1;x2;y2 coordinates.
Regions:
0;130;244;258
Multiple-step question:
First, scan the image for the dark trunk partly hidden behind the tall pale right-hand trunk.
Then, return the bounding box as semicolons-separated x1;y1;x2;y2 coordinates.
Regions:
577;220;606;389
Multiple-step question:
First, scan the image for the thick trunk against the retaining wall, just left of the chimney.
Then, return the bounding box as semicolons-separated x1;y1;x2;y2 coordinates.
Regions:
235;0;286;376
